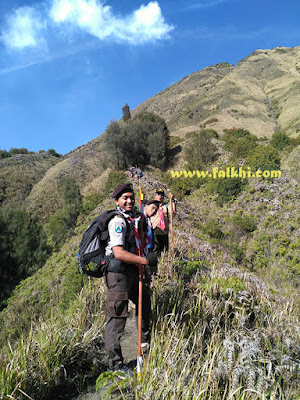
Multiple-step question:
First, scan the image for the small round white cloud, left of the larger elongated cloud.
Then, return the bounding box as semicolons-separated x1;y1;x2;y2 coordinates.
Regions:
1;7;45;49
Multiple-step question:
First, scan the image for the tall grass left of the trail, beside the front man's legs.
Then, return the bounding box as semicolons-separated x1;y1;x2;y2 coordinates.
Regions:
0;282;105;399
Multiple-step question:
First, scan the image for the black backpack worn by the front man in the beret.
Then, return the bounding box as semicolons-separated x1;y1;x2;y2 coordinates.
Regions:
78;210;128;278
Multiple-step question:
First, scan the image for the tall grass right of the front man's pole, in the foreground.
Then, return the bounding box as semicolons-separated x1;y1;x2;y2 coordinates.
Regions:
93;254;300;400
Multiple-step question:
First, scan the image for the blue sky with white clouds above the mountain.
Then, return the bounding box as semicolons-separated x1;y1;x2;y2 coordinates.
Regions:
0;0;300;154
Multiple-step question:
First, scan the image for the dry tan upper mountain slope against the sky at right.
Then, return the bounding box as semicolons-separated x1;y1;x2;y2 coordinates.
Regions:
133;47;300;137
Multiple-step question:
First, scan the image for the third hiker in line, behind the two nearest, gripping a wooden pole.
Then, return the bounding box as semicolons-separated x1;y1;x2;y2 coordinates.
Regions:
151;187;176;255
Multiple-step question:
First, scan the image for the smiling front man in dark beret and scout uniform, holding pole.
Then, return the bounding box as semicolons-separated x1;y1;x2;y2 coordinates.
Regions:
105;183;155;372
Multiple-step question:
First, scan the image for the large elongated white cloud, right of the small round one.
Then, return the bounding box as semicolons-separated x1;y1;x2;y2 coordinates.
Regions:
49;0;173;44
